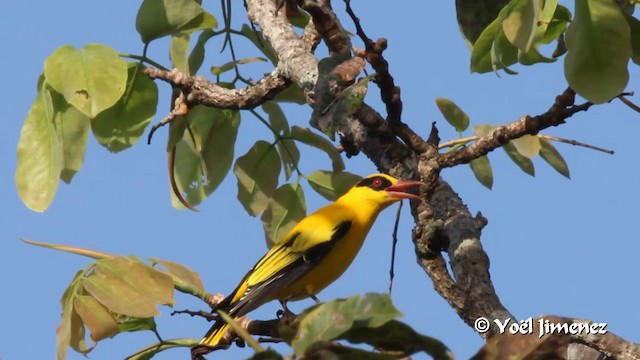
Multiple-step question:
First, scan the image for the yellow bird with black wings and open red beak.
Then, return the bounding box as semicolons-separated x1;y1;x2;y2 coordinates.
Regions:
193;174;424;354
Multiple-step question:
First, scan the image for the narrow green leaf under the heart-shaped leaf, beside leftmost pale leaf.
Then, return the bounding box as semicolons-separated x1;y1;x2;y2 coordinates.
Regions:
50;91;91;184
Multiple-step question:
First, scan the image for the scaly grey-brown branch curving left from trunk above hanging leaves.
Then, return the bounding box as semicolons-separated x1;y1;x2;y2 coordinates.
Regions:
144;68;291;109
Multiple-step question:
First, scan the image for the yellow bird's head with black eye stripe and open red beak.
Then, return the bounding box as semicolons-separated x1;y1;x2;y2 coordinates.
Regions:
342;174;426;210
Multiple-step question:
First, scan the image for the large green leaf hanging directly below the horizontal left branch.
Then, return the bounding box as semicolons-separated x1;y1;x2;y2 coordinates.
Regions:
171;106;240;209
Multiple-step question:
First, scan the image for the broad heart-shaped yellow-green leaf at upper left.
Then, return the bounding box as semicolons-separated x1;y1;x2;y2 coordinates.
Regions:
44;44;128;118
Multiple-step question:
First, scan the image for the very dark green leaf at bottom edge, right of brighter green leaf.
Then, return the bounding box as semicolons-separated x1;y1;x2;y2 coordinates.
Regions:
341;320;453;360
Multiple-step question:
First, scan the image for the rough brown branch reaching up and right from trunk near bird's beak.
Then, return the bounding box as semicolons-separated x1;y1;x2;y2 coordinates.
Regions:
437;88;592;168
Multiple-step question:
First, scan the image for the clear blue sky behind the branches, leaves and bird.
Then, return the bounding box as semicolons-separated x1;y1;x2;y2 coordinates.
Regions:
0;0;640;360
